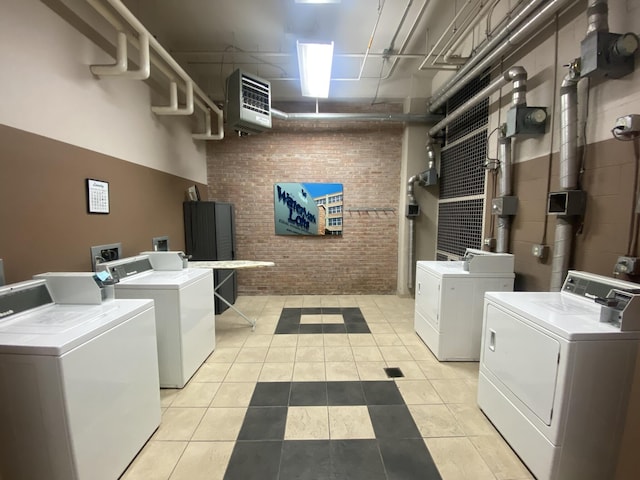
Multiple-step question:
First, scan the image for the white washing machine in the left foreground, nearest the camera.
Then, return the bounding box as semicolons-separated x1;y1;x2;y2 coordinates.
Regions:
0;274;160;480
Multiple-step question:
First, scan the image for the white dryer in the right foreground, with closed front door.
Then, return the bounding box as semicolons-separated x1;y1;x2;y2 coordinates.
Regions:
478;271;640;480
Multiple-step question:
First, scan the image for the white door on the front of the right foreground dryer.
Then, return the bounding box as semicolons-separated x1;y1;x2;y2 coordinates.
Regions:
481;302;560;425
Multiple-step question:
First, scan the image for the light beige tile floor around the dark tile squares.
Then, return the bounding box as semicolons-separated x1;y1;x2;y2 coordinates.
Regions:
122;295;533;480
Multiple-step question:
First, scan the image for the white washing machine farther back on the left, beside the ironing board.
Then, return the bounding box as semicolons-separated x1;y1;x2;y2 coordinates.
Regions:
96;252;216;388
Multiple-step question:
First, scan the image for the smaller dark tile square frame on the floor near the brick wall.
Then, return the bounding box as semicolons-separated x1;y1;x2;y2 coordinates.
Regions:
275;307;371;335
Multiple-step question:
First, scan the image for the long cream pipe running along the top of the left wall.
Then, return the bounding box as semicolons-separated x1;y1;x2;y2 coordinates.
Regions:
87;0;224;140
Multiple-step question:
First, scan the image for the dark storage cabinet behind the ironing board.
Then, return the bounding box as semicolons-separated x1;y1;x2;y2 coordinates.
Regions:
183;202;238;313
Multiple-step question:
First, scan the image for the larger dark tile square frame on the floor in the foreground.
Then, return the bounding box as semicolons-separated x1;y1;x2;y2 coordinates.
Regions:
224;380;442;480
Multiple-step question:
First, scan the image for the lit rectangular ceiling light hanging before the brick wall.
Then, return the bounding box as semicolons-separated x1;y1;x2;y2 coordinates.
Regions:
297;41;333;98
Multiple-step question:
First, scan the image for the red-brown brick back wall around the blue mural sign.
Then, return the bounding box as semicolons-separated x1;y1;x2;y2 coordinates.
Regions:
207;105;402;295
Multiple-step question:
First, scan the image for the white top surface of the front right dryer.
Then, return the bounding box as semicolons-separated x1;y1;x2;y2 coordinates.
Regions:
485;292;640;341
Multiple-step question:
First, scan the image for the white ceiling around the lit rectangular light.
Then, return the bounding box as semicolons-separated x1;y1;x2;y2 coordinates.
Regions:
123;0;460;102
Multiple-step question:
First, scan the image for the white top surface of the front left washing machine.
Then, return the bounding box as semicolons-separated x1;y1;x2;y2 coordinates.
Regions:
0;299;153;356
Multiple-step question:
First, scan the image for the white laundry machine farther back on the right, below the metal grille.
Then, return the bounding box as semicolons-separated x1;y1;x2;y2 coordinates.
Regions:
414;249;514;361
